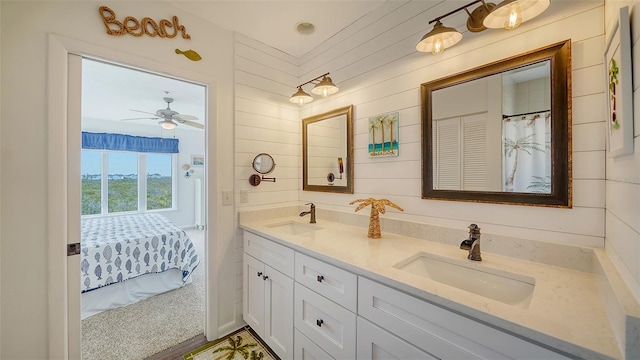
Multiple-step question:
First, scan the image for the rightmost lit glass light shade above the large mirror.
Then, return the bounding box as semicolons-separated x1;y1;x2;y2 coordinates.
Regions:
482;0;550;30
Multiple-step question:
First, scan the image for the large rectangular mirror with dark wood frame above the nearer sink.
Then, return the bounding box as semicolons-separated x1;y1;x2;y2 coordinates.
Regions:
421;40;571;208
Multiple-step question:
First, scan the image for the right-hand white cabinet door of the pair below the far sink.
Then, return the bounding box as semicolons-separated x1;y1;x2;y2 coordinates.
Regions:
262;265;293;359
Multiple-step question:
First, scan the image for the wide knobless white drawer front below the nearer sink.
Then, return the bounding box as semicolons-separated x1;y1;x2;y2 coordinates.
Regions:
358;277;567;360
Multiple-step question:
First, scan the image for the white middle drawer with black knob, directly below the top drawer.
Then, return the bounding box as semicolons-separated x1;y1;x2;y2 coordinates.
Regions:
294;283;356;359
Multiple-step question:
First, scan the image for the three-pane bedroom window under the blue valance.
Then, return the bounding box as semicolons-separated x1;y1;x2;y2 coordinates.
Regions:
81;150;175;215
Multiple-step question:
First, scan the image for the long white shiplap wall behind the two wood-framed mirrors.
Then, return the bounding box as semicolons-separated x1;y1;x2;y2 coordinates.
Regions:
300;0;605;247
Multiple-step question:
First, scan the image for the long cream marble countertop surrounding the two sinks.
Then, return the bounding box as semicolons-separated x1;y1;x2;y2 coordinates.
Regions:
240;216;623;359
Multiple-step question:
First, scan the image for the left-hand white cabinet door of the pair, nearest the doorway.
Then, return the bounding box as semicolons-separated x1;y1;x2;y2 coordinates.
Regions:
242;253;265;337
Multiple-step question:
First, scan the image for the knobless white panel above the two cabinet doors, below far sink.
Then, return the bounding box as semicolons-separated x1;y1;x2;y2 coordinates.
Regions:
243;231;294;278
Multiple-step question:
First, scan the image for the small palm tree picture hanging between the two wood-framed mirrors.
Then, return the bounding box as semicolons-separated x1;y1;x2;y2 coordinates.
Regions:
367;112;400;157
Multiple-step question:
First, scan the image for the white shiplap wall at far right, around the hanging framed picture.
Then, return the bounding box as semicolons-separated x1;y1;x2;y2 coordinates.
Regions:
605;0;640;302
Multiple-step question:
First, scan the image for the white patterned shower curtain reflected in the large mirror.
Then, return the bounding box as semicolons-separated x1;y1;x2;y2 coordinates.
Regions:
502;111;551;194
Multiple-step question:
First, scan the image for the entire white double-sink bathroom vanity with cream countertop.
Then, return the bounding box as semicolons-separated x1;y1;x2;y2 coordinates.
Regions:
241;210;636;359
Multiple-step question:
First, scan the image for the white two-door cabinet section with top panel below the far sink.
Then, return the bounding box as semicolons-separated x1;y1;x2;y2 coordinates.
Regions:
242;231;294;359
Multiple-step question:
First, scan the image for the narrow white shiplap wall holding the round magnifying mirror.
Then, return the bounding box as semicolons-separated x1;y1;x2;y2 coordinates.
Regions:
234;34;302;321
